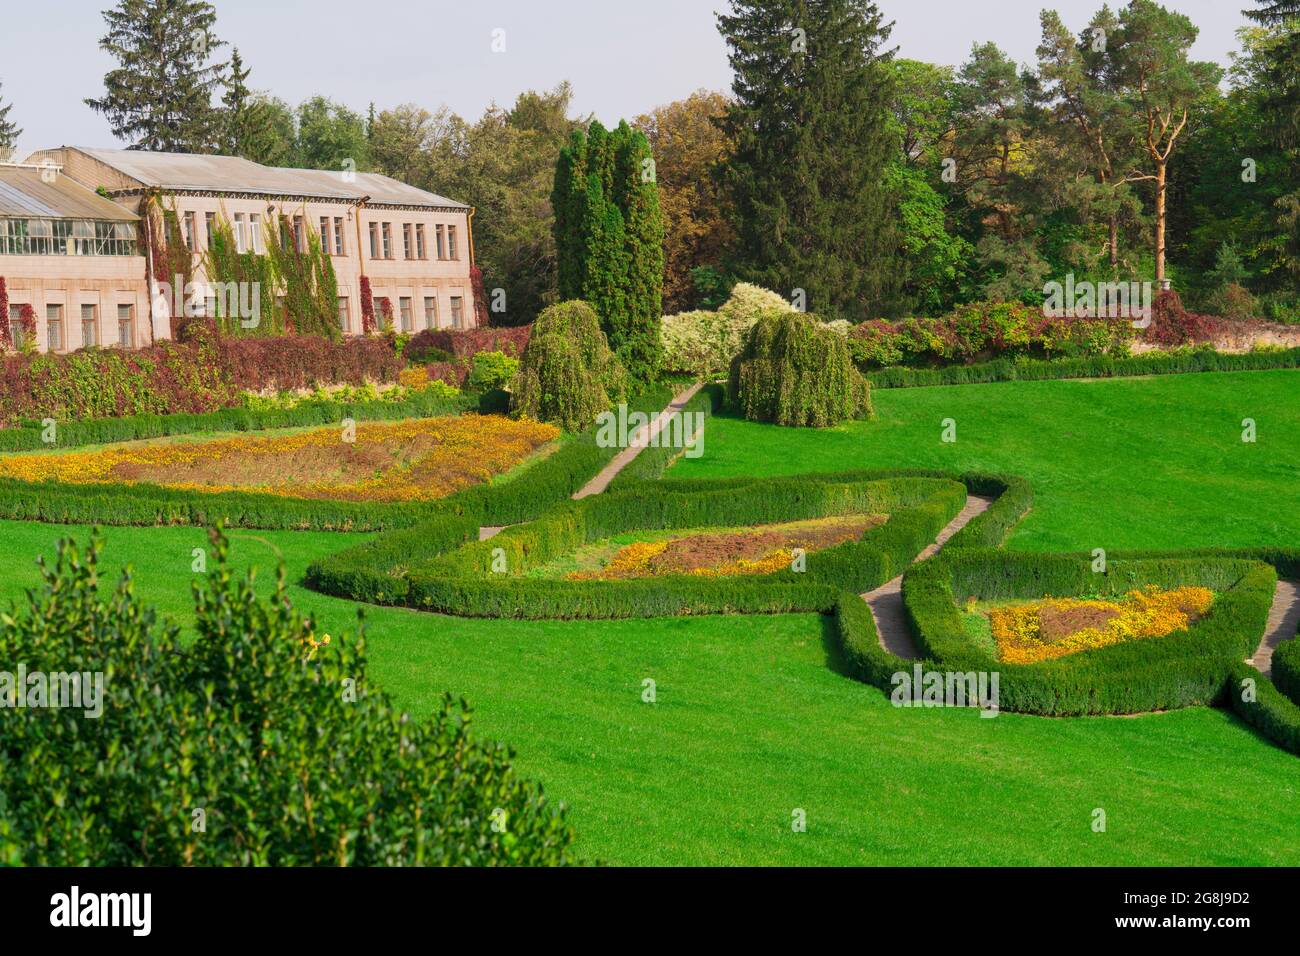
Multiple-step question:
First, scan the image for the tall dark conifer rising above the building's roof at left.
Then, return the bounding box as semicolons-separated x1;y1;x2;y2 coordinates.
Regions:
86;0;225;152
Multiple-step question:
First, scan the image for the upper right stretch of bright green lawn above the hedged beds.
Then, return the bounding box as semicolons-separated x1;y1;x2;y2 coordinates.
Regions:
668;371;1300;550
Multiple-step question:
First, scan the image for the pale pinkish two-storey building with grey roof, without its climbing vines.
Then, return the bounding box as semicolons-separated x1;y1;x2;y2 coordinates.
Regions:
0;147;476;351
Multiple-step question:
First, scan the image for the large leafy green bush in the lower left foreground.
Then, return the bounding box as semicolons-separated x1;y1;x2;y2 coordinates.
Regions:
0;532;573;866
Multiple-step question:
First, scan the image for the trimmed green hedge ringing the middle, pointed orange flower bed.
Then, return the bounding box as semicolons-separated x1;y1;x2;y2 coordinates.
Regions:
311;477;966;619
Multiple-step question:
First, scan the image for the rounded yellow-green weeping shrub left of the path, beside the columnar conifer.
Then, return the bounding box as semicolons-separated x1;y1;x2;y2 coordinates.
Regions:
511;300;628;431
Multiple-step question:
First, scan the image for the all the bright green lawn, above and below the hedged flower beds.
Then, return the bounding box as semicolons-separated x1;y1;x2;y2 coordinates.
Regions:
0;372;1300;865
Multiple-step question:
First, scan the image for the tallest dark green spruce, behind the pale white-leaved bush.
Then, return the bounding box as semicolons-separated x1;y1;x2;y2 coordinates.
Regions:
718;0;905;317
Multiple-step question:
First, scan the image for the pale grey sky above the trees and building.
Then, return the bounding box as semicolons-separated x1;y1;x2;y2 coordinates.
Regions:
0;0;1253;159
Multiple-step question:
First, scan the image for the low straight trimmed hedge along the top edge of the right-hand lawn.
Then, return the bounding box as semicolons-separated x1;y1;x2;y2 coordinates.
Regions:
865;349;1300;389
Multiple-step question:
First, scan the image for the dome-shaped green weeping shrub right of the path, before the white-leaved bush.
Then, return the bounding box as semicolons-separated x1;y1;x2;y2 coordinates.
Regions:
728;311;871;428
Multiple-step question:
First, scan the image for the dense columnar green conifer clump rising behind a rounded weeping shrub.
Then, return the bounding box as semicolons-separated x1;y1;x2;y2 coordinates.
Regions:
551;115;663;381
